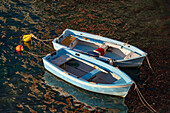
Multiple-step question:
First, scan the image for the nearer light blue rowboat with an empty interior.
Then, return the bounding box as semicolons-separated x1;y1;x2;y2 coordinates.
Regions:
43;48;133;97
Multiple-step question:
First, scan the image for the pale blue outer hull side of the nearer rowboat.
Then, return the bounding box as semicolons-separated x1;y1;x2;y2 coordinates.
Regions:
43;58;133;97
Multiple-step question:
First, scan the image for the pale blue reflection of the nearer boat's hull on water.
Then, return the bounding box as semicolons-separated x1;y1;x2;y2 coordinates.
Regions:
44;71;128;113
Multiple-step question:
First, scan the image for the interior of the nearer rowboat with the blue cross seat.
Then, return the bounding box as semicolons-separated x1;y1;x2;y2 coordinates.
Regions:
47;54;120;84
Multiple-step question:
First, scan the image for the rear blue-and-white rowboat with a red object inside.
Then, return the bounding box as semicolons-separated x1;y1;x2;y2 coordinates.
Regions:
52;29;147;67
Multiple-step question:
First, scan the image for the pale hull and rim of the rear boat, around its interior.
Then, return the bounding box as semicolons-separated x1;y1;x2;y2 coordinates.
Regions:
52;29;147;67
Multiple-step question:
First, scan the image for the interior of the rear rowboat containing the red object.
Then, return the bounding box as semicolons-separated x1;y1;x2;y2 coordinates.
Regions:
60;35;140;60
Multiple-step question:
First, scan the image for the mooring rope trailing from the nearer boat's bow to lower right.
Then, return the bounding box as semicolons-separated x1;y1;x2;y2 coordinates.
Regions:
134;82;157;113
